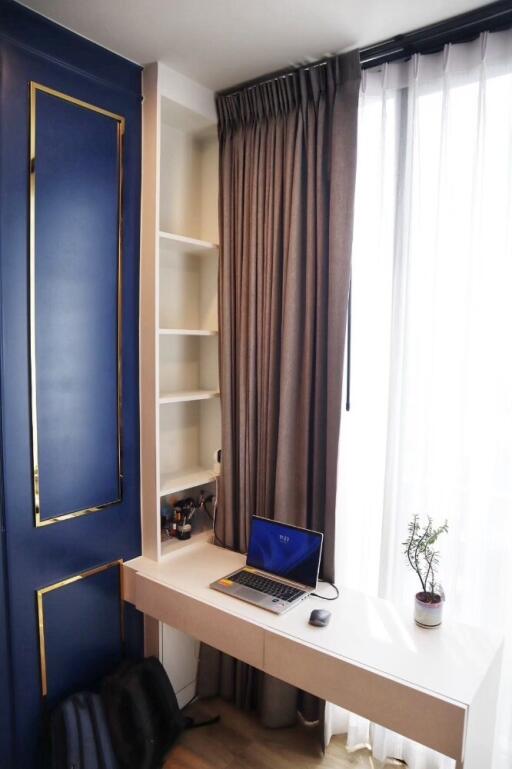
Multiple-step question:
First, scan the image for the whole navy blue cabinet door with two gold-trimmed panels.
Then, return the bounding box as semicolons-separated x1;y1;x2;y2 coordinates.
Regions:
0;3;142;769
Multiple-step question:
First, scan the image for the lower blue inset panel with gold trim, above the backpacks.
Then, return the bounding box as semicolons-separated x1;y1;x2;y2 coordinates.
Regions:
39;564;124;705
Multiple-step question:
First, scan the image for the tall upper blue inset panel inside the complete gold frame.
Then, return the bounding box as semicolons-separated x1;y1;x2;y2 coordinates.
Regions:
31;86;124;521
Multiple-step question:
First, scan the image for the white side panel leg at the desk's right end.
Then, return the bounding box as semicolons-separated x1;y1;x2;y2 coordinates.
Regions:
457;646;503;769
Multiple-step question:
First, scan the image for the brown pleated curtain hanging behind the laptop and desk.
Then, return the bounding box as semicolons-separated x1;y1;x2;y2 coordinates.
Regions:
199;53;360;725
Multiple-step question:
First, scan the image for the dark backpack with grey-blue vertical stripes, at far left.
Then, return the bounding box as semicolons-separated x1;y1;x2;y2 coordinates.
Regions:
50;692;119;769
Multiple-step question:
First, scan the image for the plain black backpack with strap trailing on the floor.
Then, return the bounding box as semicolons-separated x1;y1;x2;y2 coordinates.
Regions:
101;657;219;769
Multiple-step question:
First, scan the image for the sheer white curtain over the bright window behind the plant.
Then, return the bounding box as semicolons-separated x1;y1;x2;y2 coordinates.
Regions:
326;27;512;769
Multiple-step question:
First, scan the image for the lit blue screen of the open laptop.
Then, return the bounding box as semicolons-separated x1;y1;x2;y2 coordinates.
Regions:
247;515;323;588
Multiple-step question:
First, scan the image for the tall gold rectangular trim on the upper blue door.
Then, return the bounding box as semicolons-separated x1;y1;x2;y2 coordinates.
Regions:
29;81;126;528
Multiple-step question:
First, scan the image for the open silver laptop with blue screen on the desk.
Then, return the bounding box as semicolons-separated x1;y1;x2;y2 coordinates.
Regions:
210;515;324;614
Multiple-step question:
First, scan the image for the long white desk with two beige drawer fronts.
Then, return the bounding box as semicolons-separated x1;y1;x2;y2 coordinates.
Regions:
123;542;502;769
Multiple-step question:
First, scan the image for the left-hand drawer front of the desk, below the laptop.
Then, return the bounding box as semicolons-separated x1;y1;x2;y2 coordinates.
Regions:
132;573;264;670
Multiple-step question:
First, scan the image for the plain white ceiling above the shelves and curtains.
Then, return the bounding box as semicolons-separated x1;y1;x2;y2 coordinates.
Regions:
19;0;492;90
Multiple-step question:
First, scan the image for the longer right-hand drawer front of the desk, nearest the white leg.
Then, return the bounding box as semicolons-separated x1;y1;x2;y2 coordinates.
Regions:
264;633;466;760
